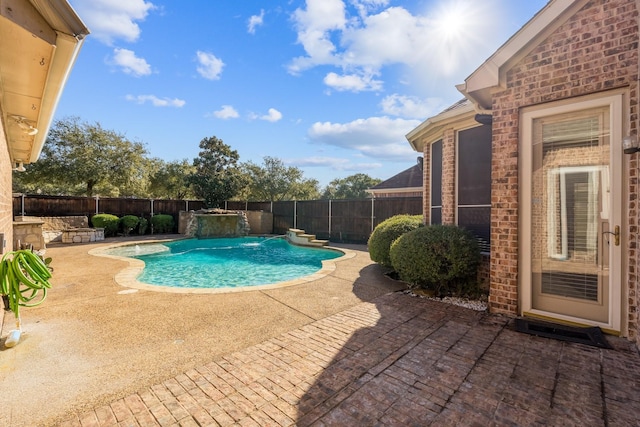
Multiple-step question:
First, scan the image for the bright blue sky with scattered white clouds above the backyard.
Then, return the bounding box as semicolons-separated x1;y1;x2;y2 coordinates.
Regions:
60;0;547;187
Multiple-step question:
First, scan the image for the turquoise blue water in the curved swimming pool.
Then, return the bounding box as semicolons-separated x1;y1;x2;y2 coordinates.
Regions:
108;237;342;288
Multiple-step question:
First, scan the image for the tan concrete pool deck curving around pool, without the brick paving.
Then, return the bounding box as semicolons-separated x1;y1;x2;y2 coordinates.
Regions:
0;236;402;427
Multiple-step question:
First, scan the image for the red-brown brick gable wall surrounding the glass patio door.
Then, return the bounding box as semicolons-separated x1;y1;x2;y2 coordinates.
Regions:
489;0;639;339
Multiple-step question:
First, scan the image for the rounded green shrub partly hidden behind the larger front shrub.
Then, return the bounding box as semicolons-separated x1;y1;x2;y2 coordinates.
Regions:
367;215;422;267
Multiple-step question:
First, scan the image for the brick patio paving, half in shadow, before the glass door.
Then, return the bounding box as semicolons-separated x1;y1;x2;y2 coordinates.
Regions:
62;293;640;427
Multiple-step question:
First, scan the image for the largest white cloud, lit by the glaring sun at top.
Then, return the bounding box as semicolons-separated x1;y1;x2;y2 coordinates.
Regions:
288;0;500;90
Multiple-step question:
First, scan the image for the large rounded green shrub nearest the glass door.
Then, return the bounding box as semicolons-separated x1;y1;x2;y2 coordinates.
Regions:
390;225;480;297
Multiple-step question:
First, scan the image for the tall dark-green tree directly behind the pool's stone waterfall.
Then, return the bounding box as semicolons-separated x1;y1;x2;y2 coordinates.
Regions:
189;136;242;207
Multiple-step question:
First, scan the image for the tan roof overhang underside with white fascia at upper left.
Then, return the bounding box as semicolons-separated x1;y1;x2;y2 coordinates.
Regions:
0;0;89;163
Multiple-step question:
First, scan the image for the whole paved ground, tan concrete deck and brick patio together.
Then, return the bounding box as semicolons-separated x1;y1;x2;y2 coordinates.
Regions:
0;236;640;427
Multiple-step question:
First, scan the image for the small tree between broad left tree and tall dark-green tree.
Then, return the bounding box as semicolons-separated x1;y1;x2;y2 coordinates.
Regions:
149;158;195;199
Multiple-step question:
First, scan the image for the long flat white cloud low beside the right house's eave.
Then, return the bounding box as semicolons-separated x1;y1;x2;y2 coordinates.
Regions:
308;117;420;160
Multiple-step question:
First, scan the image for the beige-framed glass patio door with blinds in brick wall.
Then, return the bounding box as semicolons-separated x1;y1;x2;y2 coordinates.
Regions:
523;98;620;332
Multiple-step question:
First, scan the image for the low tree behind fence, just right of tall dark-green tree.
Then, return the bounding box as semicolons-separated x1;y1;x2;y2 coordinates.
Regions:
242;156;319;202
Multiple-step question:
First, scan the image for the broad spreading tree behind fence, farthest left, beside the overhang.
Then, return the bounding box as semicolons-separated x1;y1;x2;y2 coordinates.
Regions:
15;117;147;197
